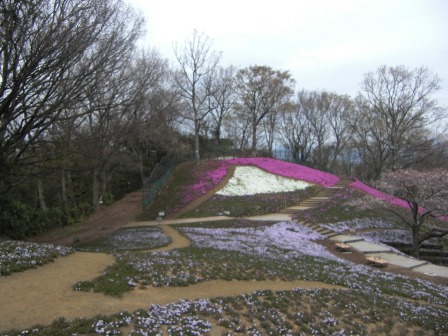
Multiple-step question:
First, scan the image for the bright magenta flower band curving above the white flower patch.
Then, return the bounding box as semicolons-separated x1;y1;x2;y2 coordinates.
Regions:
226;158;339;188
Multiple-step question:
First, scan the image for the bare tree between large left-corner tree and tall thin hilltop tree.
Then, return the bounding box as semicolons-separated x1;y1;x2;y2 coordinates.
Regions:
79;49;167;210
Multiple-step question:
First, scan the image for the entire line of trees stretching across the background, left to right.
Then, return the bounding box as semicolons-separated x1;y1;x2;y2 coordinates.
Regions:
0;0;446;237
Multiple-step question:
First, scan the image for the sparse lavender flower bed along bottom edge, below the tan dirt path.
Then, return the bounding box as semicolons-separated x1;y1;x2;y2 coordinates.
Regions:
8;289;448;336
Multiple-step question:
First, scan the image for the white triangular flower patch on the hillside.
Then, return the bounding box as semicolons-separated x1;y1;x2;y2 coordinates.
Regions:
216;166;311;196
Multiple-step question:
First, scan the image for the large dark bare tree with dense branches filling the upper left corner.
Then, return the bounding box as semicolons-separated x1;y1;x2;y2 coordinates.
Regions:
0;0;143;190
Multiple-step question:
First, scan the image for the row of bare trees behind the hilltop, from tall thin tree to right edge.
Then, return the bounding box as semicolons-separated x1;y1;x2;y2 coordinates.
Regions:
175;32;447;180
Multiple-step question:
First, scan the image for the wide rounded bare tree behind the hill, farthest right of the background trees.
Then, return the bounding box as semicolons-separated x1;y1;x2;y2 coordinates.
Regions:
351;66;446;179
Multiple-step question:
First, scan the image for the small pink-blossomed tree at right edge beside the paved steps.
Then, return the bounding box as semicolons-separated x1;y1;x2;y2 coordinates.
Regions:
377;168;448;257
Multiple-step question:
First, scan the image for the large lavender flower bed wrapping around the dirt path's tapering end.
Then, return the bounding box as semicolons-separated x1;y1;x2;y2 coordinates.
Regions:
8;221;448;336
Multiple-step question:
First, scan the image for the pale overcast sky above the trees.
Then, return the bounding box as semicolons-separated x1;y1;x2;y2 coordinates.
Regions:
125;0;448;105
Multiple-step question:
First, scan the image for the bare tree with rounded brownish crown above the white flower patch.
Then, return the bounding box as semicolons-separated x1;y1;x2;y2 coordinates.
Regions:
236;65;294;155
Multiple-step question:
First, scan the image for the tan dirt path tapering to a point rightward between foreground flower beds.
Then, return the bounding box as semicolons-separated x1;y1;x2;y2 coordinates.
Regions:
0;253;343;331
